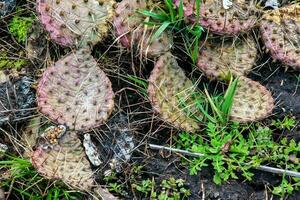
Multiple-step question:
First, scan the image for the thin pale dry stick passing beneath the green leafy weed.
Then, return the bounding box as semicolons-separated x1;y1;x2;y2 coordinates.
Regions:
149;144;300;178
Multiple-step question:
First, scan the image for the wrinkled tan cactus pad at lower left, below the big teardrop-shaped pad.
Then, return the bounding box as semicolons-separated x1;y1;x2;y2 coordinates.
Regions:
31;132;94;190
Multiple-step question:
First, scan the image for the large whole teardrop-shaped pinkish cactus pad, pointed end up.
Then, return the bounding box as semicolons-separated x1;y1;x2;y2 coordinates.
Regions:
37;49;114;130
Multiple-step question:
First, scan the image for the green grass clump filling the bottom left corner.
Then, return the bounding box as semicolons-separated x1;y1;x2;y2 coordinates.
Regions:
0;155;84;200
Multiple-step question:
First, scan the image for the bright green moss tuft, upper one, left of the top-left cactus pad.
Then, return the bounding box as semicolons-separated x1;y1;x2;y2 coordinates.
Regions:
8;15;34;44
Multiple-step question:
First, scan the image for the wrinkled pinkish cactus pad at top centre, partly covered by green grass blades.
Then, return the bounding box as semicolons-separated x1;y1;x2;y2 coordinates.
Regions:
114;0;172;57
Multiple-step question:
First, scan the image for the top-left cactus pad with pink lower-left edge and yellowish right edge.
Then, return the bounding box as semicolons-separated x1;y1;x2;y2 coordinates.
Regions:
37;0;115;46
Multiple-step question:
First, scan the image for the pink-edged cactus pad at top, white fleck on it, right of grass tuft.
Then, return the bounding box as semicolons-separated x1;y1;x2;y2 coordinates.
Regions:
174;0;257;35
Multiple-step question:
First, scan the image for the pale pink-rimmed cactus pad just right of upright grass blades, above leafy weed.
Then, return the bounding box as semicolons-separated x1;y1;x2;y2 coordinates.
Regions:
230;77;274;122
